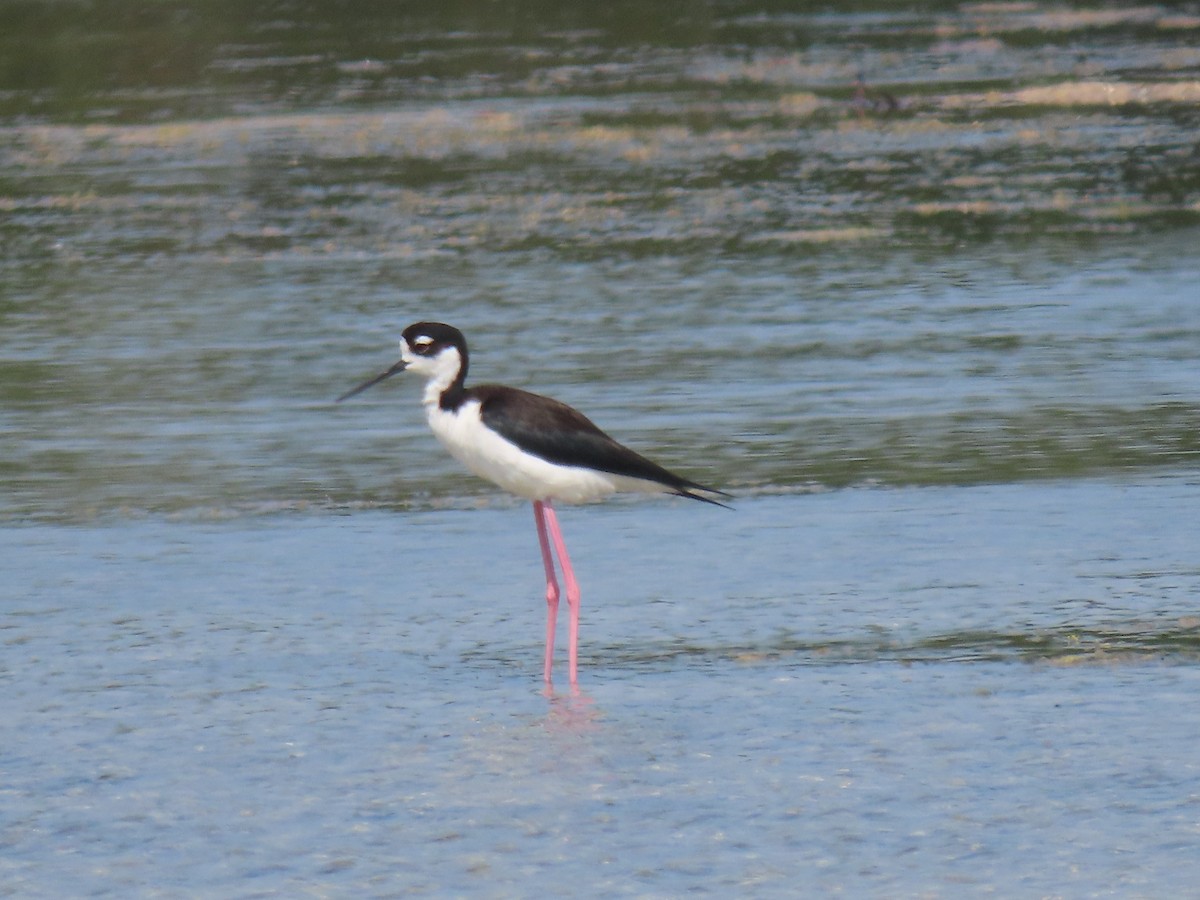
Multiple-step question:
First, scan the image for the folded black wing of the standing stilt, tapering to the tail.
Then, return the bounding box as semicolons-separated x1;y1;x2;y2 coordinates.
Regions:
469;384;728;506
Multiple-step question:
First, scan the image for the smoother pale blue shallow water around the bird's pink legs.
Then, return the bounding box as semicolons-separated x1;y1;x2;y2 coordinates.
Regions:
0;479;1200;896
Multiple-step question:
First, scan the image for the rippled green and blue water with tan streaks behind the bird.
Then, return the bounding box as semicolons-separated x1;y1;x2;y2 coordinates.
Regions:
0;5;1200;518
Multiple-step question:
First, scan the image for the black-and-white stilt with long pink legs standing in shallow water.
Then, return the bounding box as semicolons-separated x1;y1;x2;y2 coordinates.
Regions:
337;322;728;685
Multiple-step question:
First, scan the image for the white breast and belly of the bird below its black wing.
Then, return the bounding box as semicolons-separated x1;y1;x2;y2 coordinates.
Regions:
425;400;648;503
